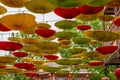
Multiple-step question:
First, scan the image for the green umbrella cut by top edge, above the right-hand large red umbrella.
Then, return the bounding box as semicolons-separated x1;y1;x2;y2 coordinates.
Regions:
87;0;111;6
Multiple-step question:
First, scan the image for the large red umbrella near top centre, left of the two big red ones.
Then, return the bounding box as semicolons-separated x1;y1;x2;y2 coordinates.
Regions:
54;7;80;19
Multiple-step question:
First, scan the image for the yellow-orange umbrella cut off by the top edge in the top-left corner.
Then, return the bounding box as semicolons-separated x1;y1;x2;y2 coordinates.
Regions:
0;0;29;8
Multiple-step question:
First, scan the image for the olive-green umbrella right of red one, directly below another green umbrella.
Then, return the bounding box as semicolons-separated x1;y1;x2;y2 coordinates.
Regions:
55;31;75;39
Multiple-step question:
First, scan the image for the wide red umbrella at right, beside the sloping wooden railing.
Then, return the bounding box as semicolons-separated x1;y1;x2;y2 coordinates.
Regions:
96;46;118;54
